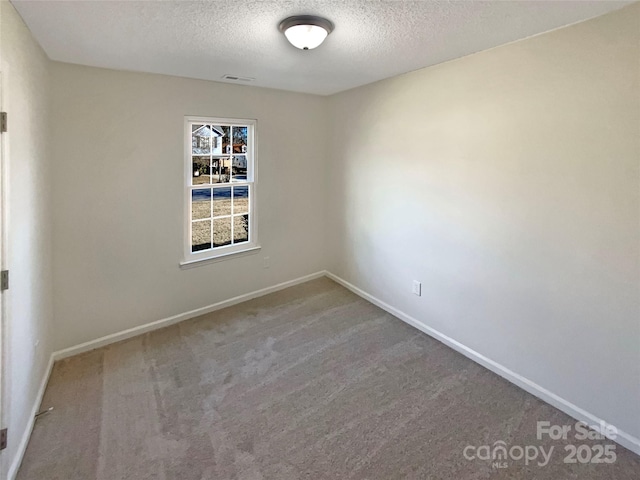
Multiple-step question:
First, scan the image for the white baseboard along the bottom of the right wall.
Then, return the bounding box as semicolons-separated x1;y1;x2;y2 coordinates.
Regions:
326;272;640;455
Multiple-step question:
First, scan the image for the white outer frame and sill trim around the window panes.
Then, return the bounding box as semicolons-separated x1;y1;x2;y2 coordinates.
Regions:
180;116;260;268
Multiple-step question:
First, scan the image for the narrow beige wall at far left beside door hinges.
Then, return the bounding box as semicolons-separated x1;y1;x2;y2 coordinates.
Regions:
0;1;53;478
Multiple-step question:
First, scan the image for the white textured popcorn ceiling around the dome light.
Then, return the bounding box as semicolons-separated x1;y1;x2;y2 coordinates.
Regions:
12;0;633;95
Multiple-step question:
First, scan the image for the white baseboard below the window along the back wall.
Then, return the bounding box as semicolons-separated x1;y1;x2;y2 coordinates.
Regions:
53;271;326;360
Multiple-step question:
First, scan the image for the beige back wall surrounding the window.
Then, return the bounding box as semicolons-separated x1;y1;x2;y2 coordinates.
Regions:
52;63;327;349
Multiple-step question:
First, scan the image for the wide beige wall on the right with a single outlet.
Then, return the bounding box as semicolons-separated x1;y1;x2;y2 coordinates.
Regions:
327;4;640;438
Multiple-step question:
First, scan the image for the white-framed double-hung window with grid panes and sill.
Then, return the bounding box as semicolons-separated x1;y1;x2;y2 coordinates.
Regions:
183;117;258;264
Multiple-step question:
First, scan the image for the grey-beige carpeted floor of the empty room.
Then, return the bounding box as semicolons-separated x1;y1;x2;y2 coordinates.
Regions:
18;279;640;480
